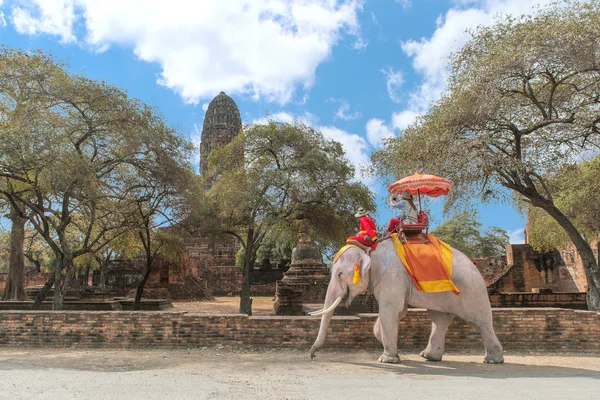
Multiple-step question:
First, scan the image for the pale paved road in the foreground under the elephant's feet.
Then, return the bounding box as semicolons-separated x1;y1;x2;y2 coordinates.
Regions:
0;348;600;400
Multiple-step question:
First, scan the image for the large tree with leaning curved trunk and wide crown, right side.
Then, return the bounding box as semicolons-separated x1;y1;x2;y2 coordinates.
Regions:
373;0;600;310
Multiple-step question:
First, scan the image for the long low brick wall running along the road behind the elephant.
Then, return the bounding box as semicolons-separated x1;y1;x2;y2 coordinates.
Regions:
0;309;600;354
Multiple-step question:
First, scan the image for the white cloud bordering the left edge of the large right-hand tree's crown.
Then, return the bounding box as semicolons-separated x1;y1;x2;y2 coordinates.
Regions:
392;0;552;135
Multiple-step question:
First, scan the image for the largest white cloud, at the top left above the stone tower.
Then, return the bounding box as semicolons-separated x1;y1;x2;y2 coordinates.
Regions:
5;0;366;104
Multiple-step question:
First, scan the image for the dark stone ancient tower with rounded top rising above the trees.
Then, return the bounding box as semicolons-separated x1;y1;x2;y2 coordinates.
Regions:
200;92;242;175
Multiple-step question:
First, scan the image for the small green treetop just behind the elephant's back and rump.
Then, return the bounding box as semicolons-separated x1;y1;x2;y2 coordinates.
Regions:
431;213;509;258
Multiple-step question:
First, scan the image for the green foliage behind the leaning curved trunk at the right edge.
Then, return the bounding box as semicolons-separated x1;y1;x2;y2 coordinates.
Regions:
524;157;600;251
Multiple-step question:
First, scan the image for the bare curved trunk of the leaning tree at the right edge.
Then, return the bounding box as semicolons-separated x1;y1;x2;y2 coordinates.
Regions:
532;199;600;311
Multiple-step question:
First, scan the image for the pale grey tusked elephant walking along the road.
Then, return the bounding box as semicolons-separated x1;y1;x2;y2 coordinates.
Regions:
309;240;504;364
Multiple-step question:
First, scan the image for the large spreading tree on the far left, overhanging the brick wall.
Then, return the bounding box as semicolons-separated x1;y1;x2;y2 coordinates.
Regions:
0;48;189;309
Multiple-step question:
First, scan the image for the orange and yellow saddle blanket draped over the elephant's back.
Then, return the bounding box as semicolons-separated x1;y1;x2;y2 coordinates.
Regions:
391;233;460;295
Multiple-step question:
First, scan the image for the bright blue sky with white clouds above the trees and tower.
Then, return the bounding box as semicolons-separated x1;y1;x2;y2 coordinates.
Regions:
0;0;549;243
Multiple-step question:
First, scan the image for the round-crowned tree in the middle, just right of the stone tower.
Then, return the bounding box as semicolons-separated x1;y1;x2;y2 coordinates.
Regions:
208;121;375;314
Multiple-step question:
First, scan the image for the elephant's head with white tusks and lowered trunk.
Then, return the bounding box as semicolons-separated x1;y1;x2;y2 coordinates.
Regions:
310;248;371;359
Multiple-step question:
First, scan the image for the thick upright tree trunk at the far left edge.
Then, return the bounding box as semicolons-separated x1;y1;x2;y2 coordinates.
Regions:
2;206;29;301
